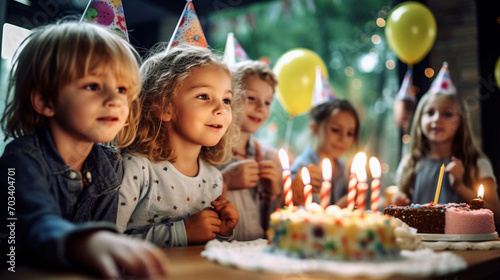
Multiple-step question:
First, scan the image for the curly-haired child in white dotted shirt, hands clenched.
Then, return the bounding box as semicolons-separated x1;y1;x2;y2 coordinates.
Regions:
117;45;243;247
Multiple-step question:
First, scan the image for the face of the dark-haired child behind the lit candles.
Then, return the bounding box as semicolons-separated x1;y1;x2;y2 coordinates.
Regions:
318;110;356;158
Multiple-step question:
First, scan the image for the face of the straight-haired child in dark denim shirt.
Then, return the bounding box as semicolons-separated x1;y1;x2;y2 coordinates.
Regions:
50;71;129;143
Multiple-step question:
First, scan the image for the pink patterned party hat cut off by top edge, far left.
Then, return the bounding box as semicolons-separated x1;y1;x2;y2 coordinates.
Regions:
80;0;129;41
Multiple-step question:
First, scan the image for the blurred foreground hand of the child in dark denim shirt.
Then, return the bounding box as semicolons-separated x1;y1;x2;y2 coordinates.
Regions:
68;231;169;279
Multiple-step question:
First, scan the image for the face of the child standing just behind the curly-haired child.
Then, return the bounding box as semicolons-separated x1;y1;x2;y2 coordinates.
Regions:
242;76;273;133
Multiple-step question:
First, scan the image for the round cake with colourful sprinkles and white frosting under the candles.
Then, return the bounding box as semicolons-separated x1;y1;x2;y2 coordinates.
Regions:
267;203;408;260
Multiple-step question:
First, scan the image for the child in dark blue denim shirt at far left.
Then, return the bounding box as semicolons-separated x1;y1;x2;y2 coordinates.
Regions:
0;22;167;278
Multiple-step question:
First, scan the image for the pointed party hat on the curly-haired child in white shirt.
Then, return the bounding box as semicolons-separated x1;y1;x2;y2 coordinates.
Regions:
167;0;208;52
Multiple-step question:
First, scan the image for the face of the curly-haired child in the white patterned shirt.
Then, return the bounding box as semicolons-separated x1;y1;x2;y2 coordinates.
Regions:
171;66;233;147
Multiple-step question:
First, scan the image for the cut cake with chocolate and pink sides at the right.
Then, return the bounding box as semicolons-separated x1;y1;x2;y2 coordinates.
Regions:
383;203;495;234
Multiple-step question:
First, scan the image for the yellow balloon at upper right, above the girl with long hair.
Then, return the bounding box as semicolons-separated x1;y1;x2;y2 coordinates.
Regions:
385;1;437;65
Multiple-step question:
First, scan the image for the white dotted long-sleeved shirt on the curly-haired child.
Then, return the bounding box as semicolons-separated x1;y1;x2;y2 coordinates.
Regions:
117;154;222;247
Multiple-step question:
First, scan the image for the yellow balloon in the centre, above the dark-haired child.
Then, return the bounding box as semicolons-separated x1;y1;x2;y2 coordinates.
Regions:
273;49;328;117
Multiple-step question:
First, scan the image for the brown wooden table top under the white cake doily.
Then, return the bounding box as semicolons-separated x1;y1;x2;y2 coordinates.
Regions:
0;246;500;280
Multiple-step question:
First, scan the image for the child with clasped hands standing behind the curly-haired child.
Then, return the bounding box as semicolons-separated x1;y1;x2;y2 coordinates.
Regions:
219;61;283;241
